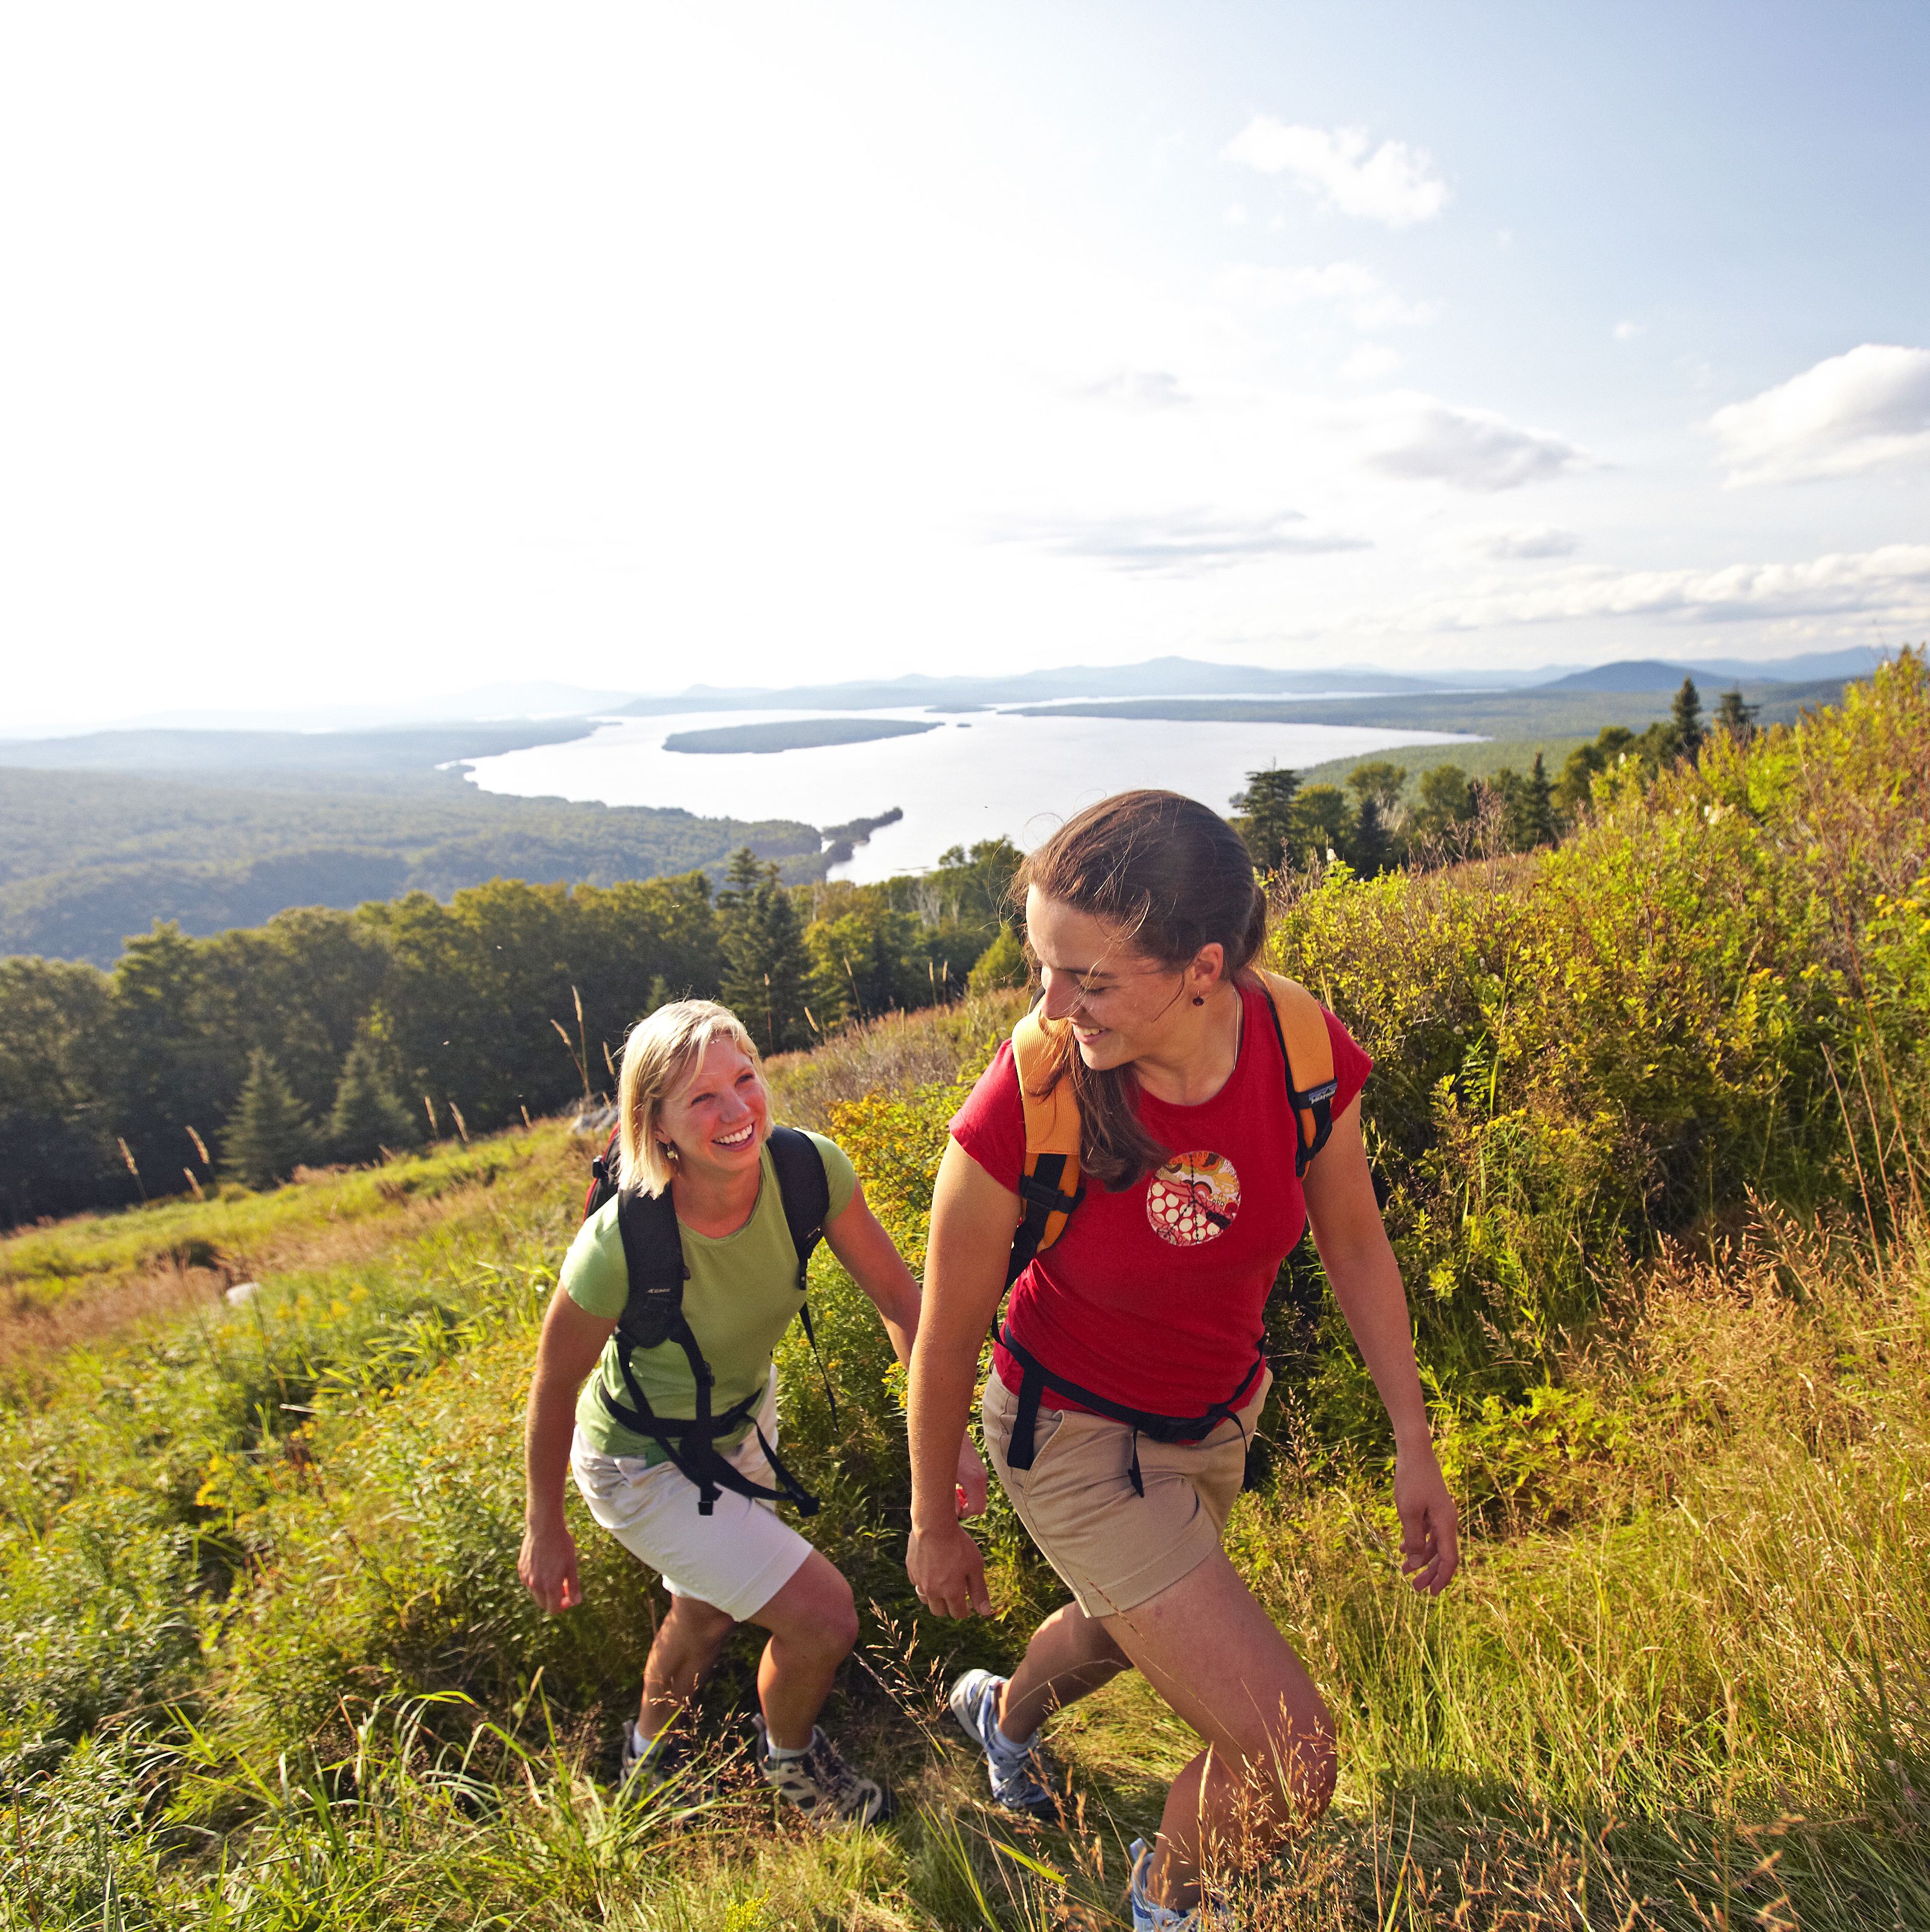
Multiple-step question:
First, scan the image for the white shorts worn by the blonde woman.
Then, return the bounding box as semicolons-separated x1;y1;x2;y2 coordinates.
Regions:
570;1366;812;1623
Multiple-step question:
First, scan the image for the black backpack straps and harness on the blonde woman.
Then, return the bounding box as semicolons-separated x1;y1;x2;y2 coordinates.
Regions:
583;1127;838;1517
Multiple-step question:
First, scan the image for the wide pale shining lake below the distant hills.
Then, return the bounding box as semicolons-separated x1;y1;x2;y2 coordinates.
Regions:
472;707;1455;883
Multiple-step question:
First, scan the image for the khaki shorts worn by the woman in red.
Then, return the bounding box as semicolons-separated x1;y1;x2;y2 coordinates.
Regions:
986;1370;1273;1617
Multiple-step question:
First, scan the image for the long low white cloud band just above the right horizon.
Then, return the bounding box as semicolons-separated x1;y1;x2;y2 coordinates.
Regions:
1405;543;1930;630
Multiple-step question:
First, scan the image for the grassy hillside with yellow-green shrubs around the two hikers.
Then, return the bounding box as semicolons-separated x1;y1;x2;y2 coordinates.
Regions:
0;665;1930;1932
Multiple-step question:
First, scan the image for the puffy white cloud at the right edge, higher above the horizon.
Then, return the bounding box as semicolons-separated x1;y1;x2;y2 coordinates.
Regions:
1708;342;1930;483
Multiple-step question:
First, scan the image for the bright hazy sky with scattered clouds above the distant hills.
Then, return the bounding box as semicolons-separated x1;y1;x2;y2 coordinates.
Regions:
0;0;1930;734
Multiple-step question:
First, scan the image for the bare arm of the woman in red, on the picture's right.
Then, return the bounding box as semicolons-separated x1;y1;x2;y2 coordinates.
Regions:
1306;1099;1461;1594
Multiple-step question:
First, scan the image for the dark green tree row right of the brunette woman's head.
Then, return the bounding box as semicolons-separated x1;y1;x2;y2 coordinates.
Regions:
1233;678;1756;877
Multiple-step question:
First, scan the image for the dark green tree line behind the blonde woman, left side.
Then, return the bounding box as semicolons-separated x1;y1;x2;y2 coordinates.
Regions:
0;840;1024;1223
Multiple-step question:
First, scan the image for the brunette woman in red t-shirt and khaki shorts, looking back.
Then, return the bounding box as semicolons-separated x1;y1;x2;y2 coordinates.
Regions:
906;792;1457;1928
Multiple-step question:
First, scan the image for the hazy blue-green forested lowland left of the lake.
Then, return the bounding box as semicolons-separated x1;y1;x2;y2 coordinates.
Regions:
0;718;829;966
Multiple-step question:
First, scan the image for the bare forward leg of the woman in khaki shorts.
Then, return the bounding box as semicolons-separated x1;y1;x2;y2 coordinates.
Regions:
1105;1549;1337;1911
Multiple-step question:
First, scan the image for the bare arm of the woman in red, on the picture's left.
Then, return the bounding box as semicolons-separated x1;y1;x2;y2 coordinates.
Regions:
904;1142;1018;1617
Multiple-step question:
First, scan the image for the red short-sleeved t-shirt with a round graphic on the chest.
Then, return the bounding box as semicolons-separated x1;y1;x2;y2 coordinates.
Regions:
952;985;1374;1416
